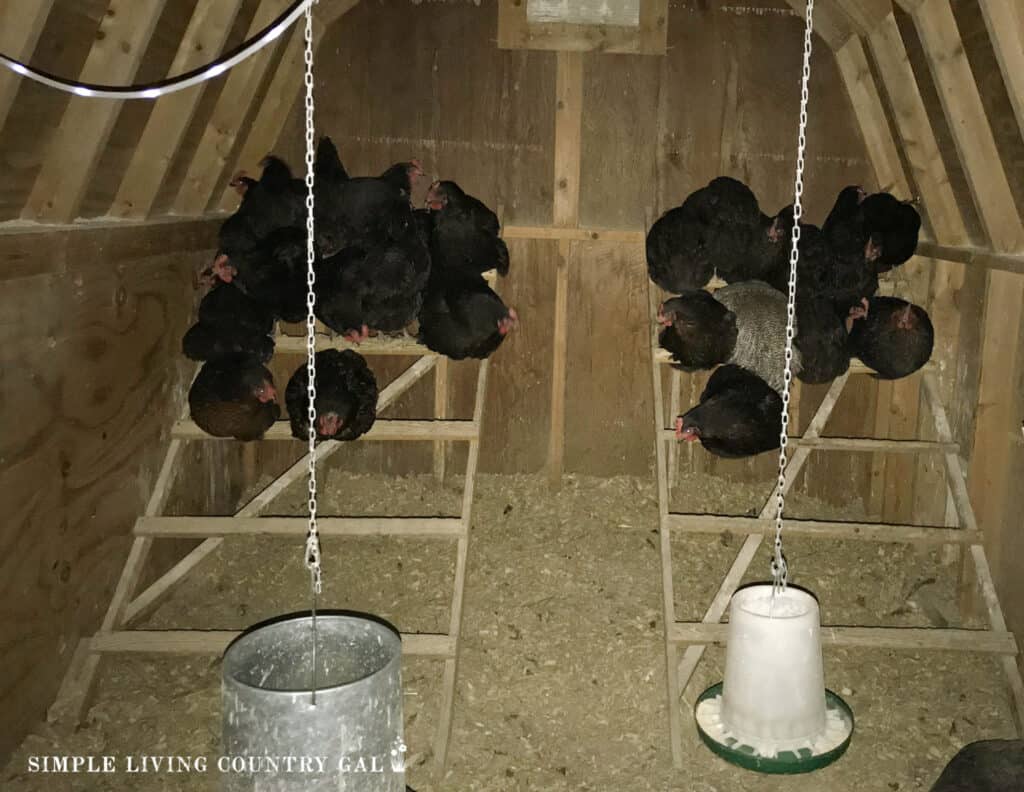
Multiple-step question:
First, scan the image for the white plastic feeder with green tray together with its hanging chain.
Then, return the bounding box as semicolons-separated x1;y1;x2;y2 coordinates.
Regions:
692;0;853;774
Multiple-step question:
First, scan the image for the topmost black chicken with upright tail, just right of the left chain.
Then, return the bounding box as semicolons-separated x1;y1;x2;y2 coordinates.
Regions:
314;137;422;256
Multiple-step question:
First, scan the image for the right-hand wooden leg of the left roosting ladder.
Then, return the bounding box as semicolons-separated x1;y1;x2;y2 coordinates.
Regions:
434;360;490;766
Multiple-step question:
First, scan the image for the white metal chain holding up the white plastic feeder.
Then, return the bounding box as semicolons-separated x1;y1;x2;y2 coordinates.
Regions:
771;0;814;596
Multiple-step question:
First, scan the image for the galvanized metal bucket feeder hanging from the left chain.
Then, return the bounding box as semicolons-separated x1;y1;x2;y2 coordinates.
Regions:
221;615;407;792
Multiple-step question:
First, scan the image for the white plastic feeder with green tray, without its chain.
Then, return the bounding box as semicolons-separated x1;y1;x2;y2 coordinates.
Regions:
696;584;853;773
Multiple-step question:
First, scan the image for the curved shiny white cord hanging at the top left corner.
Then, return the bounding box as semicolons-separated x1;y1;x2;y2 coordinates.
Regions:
0;0;318;99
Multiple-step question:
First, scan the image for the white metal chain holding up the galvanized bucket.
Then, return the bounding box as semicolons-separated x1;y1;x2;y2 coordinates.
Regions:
305;3;323;706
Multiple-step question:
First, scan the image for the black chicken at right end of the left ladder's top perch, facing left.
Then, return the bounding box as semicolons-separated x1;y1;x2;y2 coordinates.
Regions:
427;181;509;276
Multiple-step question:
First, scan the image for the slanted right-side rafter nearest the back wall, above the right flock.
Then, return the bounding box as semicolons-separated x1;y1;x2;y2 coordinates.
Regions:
836;36;910;196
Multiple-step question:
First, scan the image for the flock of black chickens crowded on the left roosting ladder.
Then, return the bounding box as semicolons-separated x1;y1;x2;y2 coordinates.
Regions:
181;137;518;441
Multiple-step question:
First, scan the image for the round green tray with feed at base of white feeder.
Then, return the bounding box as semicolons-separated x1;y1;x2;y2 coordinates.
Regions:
694;682;853;776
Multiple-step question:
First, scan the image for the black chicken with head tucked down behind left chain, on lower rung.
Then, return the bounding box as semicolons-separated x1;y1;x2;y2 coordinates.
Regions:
285;349;377;441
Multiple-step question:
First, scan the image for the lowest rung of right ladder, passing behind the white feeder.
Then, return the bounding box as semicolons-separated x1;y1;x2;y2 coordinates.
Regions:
669;622;1017;655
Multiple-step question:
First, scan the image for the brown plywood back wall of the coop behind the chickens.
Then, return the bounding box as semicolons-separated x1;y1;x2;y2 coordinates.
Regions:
278;0;873;492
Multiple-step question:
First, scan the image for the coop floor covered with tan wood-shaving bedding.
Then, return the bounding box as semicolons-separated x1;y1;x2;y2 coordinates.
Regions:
0;470;1014;792
